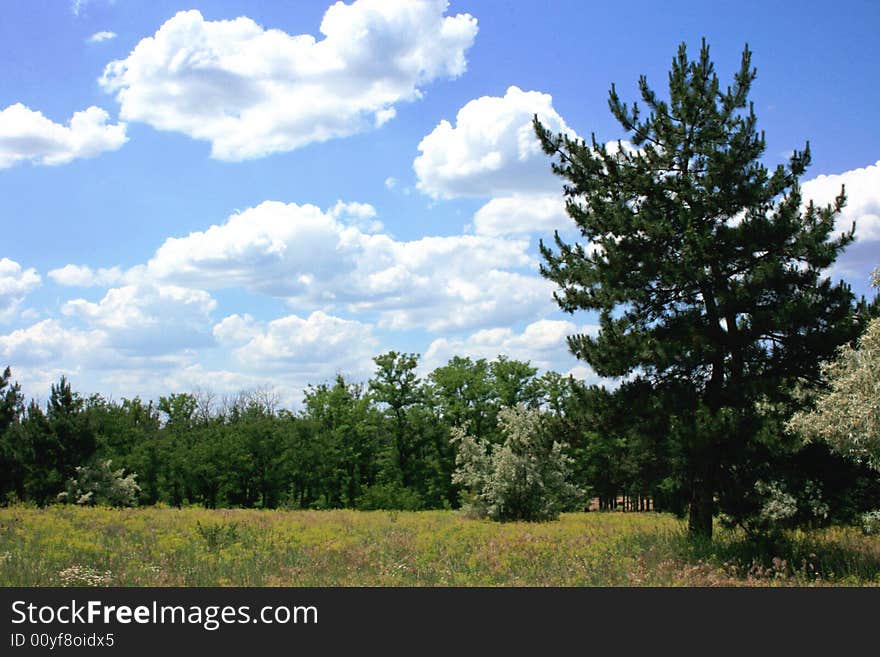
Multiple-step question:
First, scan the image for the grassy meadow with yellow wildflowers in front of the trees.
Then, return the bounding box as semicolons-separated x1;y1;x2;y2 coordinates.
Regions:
0;506;880;586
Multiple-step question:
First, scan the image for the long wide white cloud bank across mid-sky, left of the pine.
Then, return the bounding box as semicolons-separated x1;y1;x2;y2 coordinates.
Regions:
146;201;552;331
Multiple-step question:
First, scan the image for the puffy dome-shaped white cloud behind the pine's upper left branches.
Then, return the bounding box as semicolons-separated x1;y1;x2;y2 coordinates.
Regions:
413;87;576;198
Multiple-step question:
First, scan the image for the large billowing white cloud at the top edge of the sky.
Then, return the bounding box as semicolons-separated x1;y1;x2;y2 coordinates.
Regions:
101;0;477;160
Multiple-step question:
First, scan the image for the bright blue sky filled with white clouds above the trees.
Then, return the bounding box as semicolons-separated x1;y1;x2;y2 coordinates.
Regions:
0;0;880;407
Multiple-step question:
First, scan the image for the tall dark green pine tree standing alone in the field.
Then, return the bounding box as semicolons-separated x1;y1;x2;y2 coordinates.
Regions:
534;42;856;536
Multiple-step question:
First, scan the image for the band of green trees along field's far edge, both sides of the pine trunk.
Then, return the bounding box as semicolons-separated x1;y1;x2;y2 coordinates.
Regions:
0;344;880;522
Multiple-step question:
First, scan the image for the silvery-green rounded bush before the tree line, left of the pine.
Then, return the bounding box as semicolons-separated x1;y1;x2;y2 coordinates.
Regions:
452;407;583;521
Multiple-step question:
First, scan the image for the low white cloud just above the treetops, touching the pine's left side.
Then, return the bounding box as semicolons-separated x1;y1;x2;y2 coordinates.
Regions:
423;319;598;373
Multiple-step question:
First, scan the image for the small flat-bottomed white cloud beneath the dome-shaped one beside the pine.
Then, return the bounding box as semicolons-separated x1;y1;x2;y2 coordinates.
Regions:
474;194;574;235
